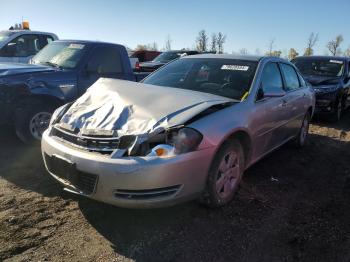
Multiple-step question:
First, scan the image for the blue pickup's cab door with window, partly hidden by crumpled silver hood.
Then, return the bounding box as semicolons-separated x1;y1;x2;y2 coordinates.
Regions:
78;46;124;95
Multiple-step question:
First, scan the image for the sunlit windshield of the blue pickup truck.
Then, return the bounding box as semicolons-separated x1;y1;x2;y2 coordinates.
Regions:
32;42;86;69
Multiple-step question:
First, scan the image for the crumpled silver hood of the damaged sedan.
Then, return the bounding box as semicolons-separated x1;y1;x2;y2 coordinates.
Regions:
59;78;234;136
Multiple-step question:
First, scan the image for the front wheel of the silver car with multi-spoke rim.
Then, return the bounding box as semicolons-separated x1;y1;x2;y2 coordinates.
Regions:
201;140;245;207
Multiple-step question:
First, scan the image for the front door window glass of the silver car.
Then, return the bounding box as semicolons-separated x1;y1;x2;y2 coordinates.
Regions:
261;63;283;93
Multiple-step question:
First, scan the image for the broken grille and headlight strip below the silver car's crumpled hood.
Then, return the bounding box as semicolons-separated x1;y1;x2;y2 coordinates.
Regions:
50;125;203;158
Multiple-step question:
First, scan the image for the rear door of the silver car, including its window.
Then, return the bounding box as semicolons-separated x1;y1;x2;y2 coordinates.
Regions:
280;63;307;139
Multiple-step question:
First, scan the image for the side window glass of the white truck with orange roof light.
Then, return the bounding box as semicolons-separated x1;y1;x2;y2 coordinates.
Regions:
2;35;41;57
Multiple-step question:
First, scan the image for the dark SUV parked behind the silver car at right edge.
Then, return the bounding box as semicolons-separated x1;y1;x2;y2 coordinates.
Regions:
292;56;350;121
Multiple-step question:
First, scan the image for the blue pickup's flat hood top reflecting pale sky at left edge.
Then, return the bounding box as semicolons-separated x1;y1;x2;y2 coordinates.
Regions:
0;63;55;76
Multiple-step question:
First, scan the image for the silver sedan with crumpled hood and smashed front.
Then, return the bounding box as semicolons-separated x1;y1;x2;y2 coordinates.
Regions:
42;54;315;208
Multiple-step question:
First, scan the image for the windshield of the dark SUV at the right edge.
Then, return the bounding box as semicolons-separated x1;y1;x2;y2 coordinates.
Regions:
294;59;344;77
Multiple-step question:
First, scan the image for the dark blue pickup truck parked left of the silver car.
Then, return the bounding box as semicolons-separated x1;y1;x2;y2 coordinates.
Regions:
0;40;147;143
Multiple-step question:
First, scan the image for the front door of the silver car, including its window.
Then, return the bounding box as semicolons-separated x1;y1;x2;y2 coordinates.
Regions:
252;62;289;158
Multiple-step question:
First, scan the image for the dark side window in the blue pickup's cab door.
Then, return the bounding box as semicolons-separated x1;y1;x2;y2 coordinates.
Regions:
88;47;123;75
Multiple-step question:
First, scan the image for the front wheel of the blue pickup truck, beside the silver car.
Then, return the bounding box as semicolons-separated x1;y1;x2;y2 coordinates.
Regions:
15;100;55;144
